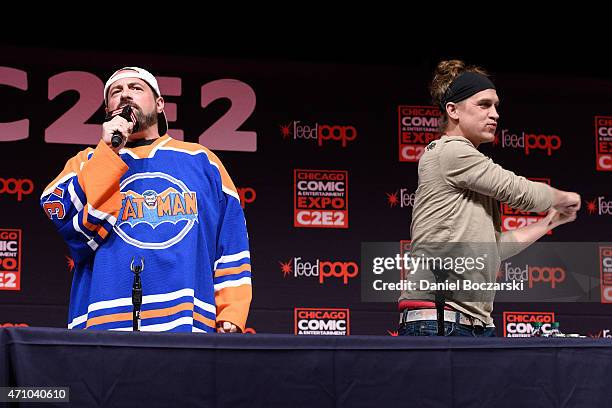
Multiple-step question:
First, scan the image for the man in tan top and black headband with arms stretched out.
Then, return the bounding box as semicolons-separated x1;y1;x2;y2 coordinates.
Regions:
399;60;580;336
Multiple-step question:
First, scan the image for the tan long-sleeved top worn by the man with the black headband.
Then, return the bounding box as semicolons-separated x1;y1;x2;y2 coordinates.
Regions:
400;136;553;325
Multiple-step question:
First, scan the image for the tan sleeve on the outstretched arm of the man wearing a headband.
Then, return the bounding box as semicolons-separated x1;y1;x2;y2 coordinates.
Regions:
440;141;552;212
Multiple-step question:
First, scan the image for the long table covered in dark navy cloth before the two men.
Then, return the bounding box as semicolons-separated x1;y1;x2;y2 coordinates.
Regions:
0;328;612;408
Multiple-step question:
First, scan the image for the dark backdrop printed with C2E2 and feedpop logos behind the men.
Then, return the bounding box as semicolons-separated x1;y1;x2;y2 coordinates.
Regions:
0;48;612;336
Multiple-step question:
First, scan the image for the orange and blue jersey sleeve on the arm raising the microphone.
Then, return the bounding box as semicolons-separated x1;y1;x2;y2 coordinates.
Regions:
40;141;128;263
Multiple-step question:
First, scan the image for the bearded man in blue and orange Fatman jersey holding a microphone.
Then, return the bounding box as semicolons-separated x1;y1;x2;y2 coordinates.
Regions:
41;67;251;333
